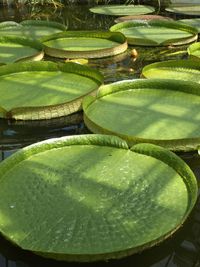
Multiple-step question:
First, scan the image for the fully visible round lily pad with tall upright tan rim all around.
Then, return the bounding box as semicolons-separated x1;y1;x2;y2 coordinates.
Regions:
43;31;127;58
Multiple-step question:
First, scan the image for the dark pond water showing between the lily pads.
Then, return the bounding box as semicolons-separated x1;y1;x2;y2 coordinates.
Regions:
0;2;200;267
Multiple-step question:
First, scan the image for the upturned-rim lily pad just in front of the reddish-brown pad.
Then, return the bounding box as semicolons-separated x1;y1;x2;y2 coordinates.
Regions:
110;20;198;46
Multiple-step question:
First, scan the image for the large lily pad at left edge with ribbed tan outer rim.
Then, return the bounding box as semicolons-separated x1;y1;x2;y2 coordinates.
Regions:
0;61;103;120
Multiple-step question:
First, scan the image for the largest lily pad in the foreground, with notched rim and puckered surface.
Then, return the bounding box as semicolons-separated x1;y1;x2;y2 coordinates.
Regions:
0;135;197;261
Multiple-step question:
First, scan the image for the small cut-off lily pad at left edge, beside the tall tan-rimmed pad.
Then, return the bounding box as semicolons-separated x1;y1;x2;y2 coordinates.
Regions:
0;36;44;64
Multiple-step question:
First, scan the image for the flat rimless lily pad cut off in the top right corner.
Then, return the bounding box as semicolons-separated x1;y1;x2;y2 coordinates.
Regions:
165;4;200;16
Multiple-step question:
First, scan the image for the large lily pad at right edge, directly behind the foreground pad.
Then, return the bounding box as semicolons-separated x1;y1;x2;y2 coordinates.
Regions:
83;79;200;150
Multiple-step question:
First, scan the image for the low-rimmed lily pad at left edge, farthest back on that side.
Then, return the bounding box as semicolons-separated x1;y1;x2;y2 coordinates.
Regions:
0;20;66;39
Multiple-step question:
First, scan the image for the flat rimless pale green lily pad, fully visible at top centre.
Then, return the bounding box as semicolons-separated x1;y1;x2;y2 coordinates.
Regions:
90;5;155;16
